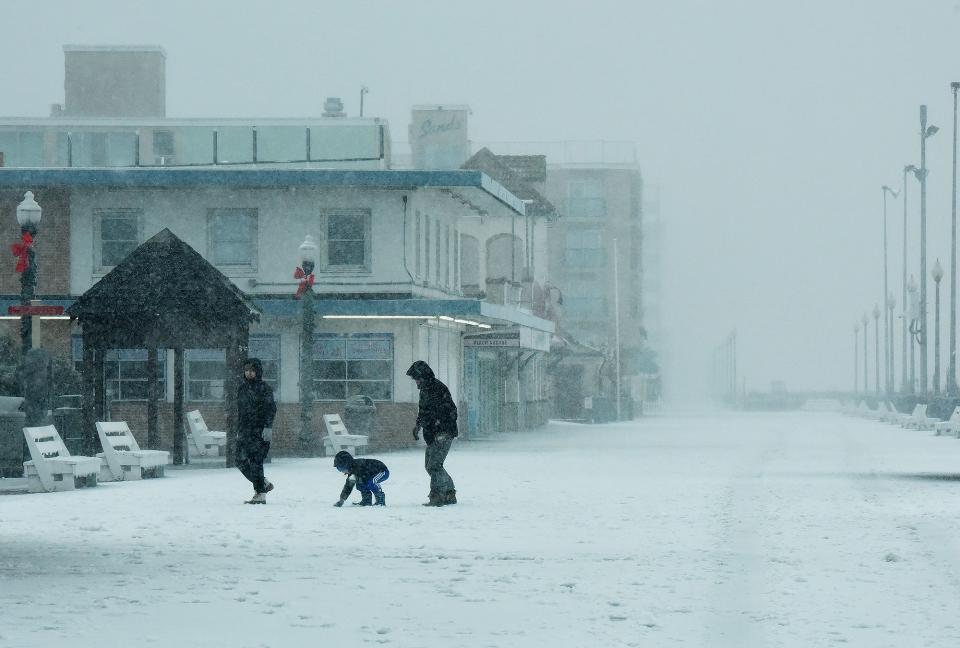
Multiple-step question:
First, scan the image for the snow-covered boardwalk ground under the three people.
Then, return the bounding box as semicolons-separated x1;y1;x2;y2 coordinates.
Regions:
0;413;960;648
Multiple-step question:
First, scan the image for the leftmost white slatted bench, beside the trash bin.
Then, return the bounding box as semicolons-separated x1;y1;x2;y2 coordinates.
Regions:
23;425;100;493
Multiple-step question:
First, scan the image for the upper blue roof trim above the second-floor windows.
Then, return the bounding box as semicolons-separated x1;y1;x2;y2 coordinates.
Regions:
0;167;524;214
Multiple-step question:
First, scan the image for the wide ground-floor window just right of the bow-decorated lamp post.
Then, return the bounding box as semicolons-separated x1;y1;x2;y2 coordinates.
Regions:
313;333;393;401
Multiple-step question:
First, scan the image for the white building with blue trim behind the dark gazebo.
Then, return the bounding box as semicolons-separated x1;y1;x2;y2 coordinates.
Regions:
0;47;554;453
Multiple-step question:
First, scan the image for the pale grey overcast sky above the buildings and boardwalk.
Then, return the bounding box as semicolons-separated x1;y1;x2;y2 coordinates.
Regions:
0;0;960;393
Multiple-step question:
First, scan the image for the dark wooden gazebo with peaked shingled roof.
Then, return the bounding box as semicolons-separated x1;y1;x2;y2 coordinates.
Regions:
67;229;260;466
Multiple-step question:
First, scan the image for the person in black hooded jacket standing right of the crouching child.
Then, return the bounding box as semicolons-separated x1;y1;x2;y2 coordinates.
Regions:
407;360;457;506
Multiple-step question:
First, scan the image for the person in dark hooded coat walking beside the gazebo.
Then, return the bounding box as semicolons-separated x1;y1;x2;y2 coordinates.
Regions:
237;358;277;504
